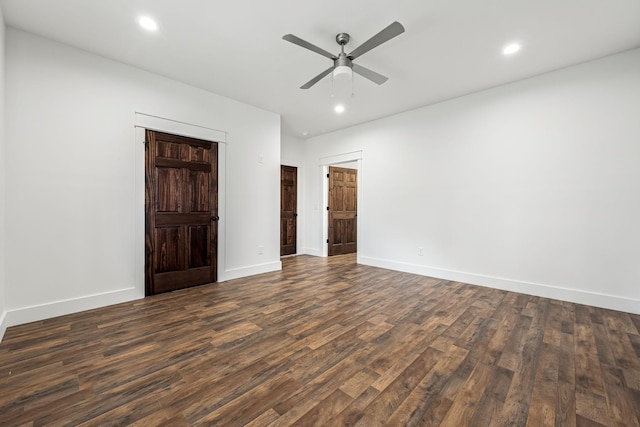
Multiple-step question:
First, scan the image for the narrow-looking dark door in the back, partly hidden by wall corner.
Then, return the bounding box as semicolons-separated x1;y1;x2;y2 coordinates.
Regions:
280;165;298;256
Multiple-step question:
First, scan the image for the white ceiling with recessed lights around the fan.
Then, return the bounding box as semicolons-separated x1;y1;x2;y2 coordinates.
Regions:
0;0;640;137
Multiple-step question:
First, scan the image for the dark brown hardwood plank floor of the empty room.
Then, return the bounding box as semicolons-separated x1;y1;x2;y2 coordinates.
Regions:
0;255;640;426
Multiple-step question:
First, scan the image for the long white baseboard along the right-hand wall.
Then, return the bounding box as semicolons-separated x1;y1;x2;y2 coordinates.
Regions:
358;256;640;314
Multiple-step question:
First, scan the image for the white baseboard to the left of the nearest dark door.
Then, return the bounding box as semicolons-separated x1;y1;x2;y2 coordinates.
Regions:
0;288;144;336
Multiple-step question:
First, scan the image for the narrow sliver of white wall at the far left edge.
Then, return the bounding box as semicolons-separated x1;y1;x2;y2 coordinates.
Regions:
0;8;7;340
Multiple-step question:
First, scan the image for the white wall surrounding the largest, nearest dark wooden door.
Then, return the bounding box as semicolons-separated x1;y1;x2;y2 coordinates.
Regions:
6;28;280;325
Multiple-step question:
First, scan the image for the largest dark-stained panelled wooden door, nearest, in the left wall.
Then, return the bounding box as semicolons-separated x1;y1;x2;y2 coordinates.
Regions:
145;130;218;295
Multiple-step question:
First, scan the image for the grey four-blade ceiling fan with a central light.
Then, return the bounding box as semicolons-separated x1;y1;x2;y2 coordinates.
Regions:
282;22;404;89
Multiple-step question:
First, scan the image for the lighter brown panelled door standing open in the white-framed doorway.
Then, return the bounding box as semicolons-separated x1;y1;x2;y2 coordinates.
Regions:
329;166;358;256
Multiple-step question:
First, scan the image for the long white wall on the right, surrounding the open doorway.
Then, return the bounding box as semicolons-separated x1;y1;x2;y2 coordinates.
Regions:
306;49;640;313
